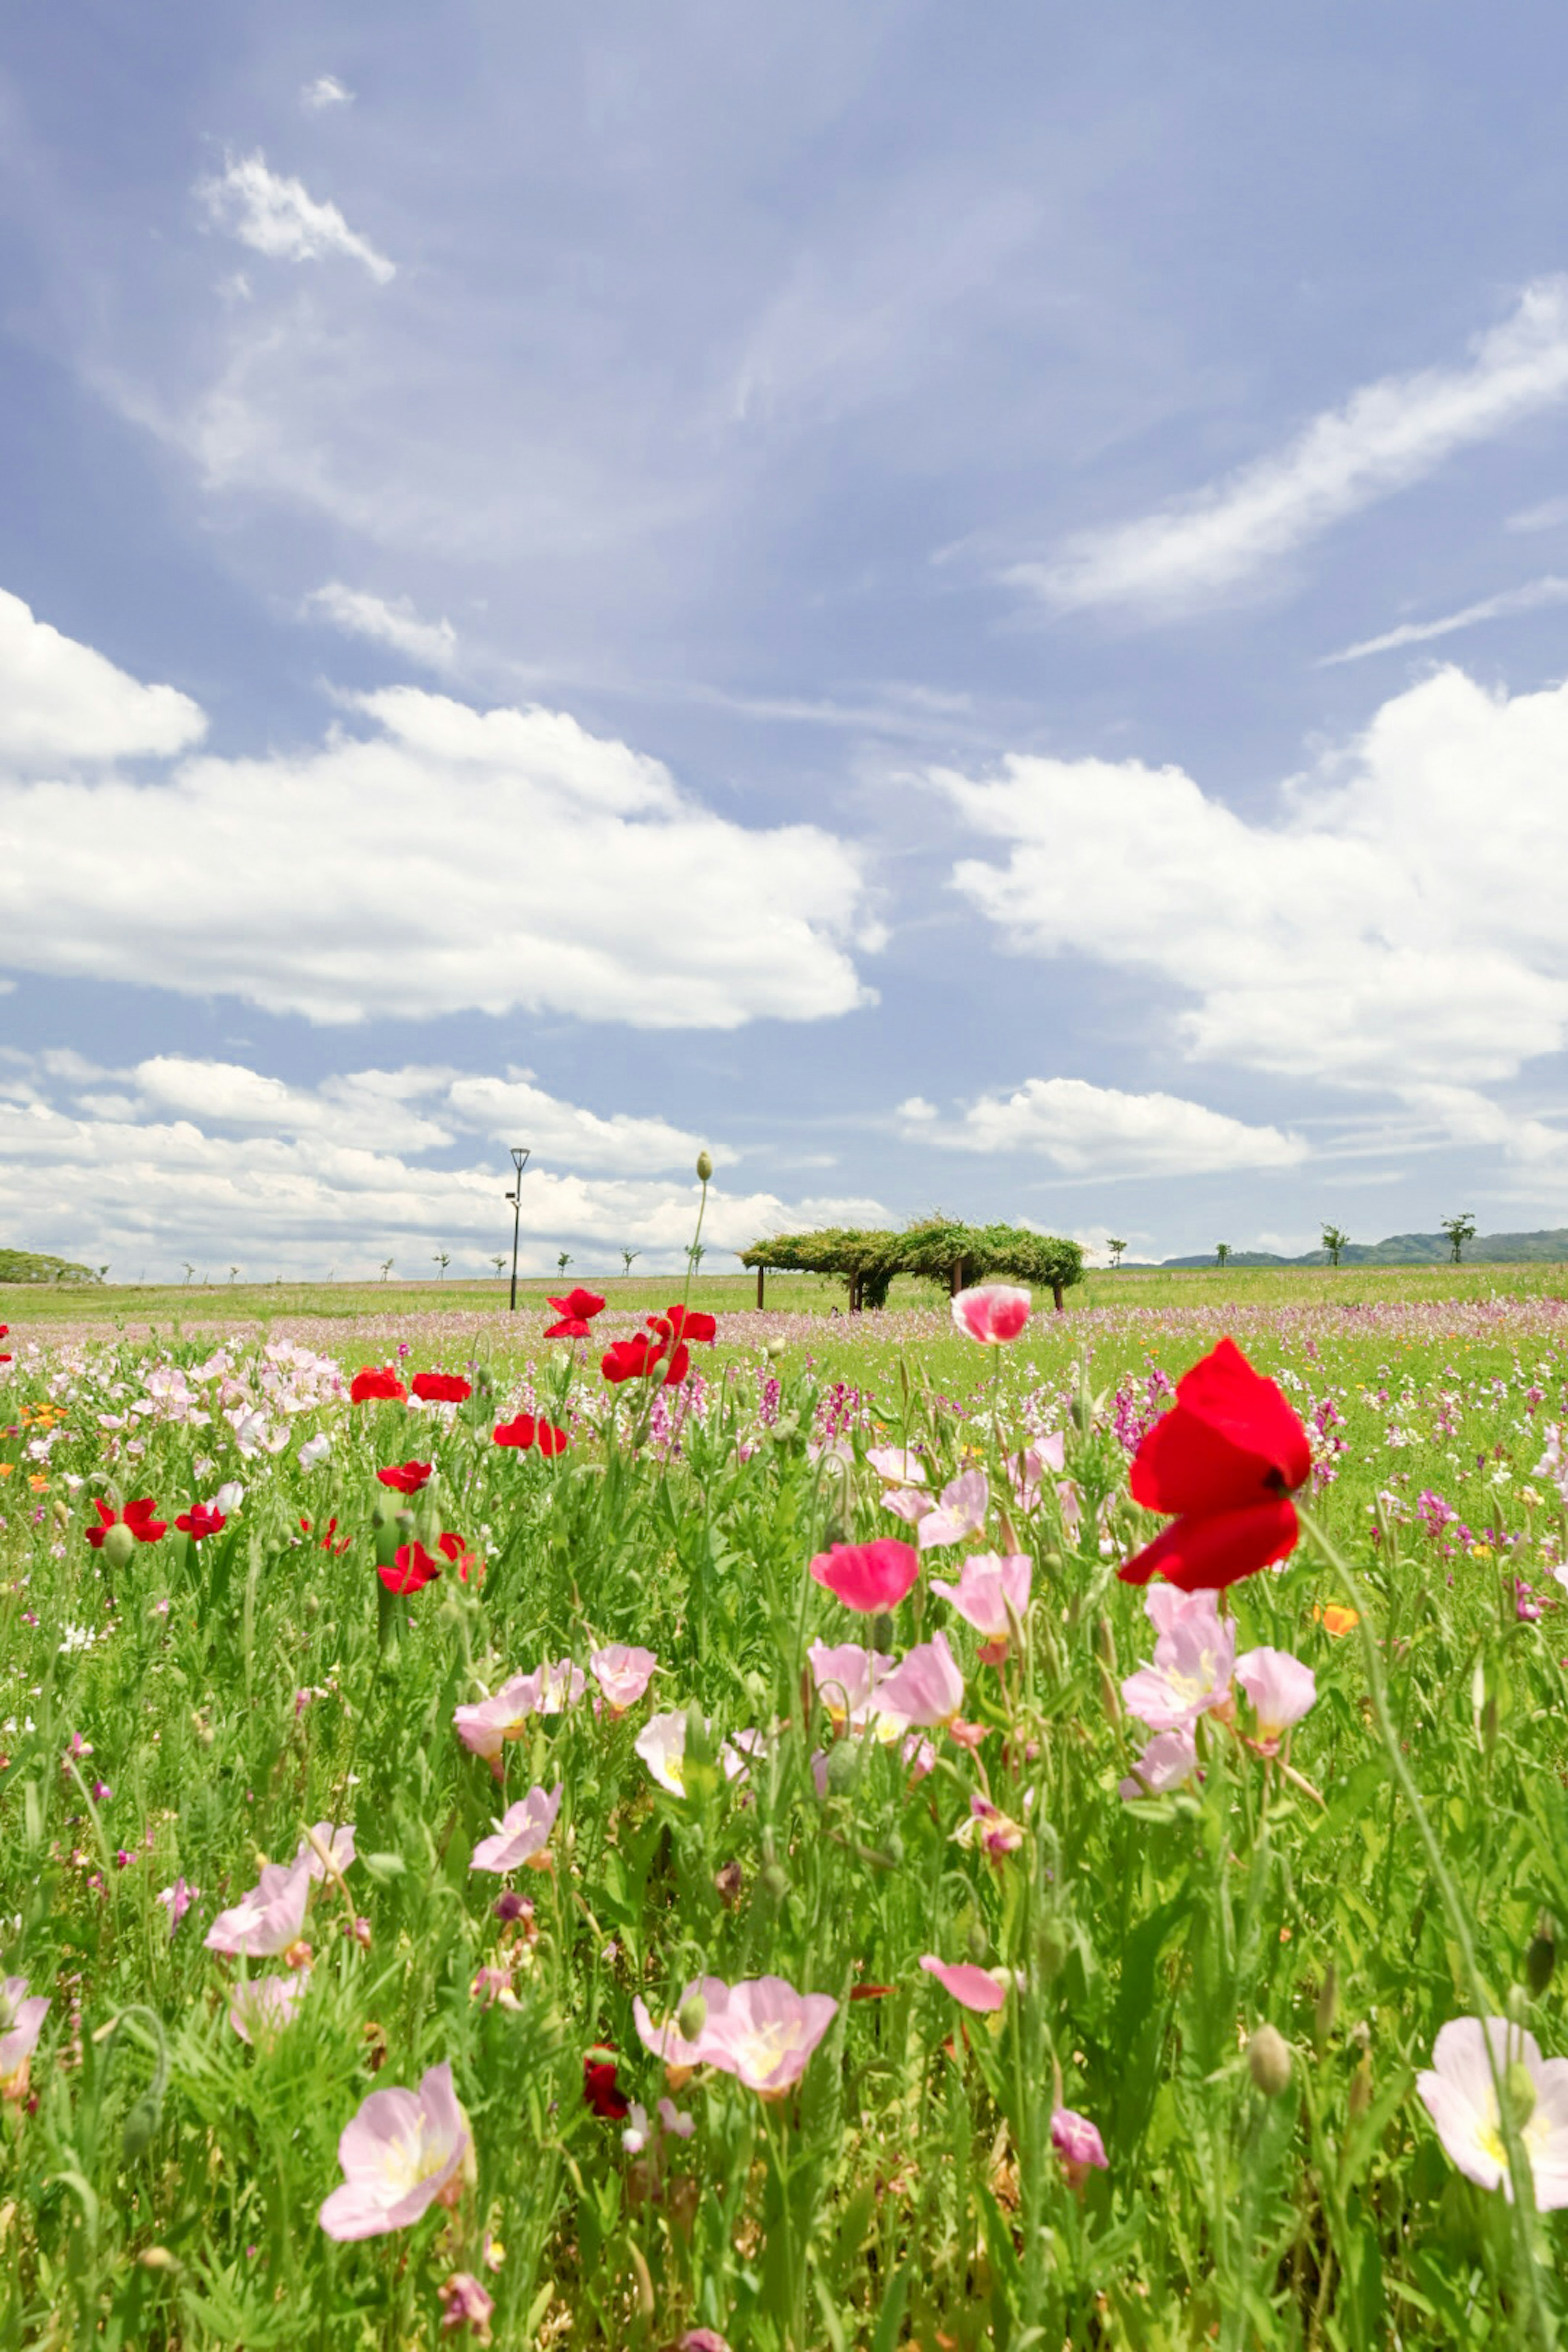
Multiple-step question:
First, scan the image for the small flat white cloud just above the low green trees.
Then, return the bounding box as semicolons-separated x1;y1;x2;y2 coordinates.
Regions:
900;1077;1307;1176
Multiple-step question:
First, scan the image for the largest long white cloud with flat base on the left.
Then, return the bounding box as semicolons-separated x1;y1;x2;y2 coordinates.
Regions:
0;607;877;1028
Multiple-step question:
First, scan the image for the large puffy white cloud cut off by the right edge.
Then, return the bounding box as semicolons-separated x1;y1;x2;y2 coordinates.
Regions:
933;668;1568;1091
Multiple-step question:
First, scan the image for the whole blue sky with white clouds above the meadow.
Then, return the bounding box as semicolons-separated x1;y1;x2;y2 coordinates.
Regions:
0;0;1568;1277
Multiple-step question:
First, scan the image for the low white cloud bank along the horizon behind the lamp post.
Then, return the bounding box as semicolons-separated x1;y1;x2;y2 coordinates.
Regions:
0;1056;886;1279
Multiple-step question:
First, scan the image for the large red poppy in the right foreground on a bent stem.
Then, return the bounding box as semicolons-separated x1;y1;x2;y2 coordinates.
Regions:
1117;1338;1312;1592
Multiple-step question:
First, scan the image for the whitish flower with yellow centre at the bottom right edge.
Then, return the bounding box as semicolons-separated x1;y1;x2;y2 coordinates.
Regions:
1415;2018;1568;2213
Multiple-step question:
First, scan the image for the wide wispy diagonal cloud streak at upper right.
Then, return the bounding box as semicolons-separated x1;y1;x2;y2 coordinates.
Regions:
1009;278;1568;609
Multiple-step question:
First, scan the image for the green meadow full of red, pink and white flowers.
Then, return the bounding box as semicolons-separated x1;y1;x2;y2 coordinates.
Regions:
0;1277;1568;2352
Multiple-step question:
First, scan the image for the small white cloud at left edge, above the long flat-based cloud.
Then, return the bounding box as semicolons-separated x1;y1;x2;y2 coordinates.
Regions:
0;588;207;766
